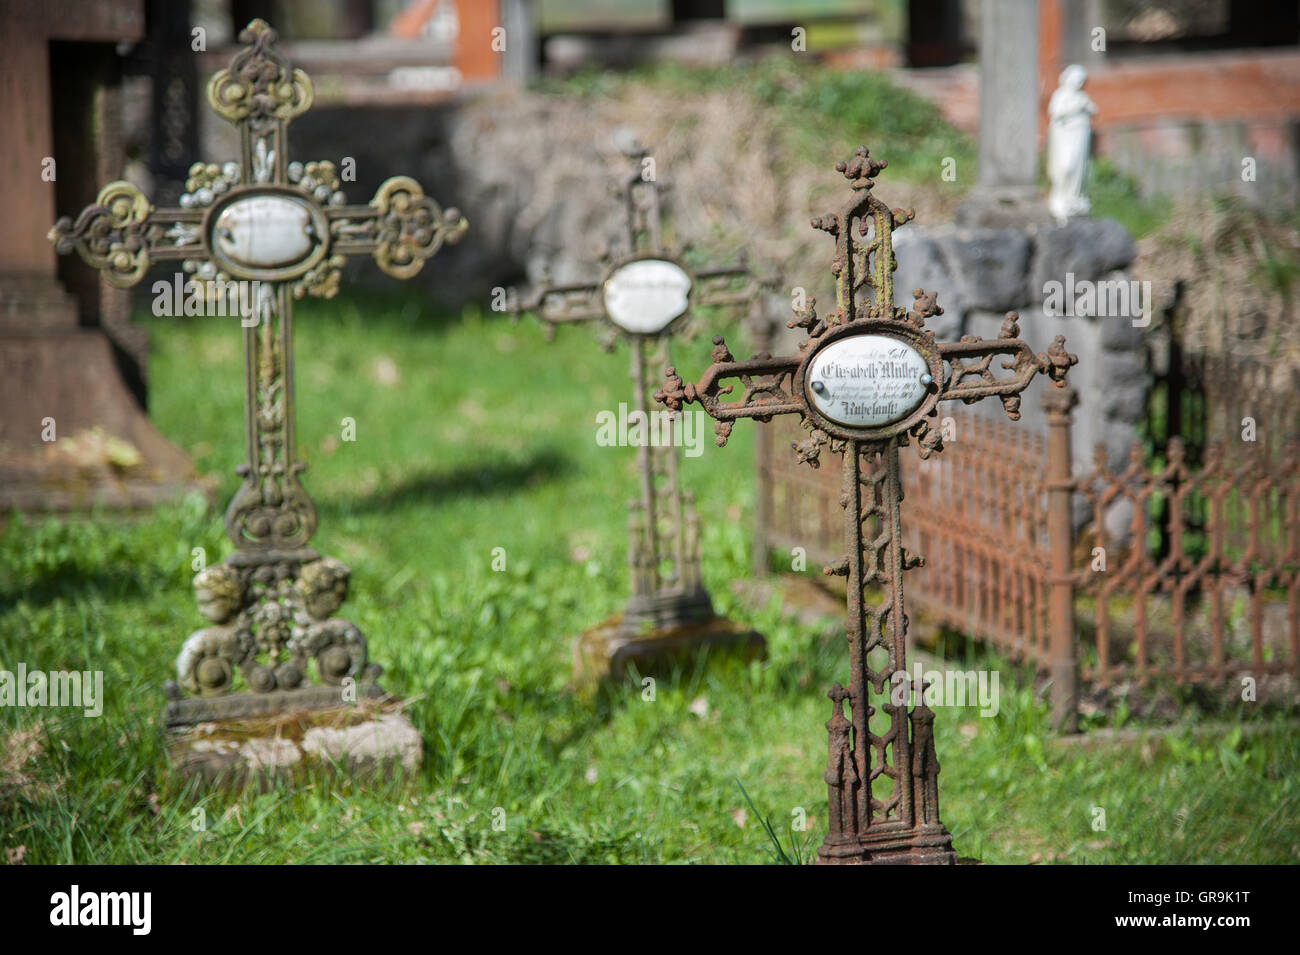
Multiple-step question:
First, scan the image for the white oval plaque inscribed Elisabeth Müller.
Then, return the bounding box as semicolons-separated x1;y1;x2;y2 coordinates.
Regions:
805;335;931;427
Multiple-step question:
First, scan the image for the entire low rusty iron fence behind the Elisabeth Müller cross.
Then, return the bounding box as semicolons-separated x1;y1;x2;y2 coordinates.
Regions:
757;384;1300;715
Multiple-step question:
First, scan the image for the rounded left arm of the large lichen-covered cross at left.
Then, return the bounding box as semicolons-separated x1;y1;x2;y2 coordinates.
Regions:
48;181;203;288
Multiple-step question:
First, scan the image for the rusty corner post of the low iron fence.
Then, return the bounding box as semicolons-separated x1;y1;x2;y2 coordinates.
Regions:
1043;386;1079;733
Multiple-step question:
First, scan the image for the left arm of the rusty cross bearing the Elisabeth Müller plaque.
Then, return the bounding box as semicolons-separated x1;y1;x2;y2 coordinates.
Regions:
654;335;806;447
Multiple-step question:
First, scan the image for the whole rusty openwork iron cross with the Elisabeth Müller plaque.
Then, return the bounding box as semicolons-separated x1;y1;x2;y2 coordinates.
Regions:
655;147;1078;864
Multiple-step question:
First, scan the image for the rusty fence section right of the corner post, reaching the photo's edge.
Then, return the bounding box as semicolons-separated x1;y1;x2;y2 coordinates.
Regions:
1074;438;1300;685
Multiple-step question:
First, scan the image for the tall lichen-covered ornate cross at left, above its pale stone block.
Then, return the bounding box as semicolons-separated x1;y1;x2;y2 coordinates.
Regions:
49;19;467;721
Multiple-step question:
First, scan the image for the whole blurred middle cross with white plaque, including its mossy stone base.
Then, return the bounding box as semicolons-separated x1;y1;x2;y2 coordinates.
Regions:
512;144;766;683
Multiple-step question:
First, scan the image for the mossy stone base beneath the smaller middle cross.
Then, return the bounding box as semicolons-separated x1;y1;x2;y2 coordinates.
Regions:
573;617;767;689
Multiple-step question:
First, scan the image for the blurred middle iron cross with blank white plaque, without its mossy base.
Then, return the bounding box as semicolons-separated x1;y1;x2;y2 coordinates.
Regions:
512;146;759;635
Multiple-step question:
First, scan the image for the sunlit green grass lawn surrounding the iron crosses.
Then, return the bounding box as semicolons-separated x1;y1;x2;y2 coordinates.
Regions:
0;287;1300;863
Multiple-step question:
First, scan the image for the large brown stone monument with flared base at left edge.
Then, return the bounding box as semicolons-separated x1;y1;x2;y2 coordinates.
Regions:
0;0;199;511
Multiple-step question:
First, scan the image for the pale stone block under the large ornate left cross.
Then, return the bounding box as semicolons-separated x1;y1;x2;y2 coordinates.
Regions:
166;699;424;787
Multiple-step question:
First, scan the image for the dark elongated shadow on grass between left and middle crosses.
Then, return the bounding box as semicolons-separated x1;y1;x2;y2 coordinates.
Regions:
319;448;573;515
